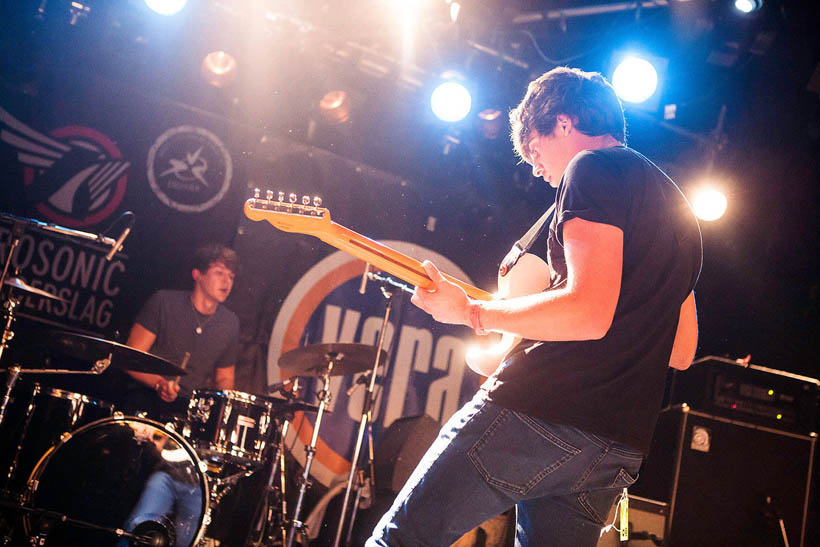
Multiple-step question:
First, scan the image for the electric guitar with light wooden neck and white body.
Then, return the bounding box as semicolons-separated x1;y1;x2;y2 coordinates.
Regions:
244;193;550;376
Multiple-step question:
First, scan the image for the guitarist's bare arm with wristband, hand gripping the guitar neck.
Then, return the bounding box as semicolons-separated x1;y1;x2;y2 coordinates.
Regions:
413;218;623;341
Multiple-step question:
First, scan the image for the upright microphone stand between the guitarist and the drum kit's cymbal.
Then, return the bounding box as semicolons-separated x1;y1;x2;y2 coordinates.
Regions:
333;271;413;547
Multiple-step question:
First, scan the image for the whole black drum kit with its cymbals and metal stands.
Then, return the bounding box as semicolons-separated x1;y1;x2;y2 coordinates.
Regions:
0;212;404;547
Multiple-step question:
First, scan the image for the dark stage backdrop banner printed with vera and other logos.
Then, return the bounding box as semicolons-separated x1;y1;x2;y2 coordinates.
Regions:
0;69;546;485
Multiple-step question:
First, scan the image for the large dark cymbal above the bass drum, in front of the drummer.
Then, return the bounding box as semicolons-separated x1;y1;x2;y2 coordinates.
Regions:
48;331;187;376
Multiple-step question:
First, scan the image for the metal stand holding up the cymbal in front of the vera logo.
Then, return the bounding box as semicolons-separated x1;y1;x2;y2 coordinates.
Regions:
251;377;299;547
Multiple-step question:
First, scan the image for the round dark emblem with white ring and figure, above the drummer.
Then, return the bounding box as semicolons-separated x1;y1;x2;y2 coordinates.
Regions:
148;125;233;213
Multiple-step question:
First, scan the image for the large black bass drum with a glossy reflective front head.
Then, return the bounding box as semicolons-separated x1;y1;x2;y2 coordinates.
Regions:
24;416;209;547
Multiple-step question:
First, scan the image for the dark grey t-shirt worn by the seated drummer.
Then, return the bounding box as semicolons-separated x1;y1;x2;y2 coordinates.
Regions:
136;290;239;393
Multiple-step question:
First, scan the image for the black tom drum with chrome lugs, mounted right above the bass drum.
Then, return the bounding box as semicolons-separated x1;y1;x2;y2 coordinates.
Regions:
183;389;271;465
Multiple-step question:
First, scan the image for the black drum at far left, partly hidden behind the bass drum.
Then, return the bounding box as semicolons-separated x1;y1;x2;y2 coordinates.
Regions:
4;384;114;494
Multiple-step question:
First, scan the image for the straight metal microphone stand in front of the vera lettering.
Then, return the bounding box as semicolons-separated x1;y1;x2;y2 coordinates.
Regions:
333;269;413;547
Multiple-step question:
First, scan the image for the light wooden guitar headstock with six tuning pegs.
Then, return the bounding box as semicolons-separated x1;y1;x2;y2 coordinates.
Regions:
245;188;330;235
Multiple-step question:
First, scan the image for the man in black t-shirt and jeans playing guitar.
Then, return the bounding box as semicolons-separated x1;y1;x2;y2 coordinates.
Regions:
367;67;702;547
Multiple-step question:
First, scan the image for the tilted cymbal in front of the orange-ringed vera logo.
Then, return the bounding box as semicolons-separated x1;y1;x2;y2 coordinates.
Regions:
279;343;387;376
